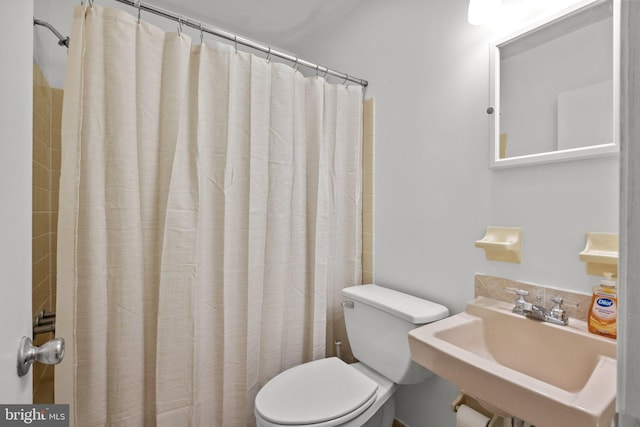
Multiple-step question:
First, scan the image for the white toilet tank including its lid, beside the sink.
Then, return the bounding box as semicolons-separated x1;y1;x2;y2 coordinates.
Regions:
342;285;449;384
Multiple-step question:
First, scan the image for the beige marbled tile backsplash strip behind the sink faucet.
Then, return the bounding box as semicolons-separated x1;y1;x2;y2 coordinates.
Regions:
475;274;591;322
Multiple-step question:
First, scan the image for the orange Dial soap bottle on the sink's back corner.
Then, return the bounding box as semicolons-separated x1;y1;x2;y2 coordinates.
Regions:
589;273;618;338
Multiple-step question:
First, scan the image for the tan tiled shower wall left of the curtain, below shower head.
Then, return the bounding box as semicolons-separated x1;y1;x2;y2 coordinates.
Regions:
32;64;62;403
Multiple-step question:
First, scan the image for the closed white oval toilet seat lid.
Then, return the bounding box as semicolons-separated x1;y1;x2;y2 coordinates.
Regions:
255;357;378;425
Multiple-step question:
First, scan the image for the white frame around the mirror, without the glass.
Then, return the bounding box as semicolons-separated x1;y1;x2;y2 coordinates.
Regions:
487;0;620;169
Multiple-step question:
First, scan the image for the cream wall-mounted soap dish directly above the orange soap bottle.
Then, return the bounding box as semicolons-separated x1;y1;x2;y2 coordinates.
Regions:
580;232;618;277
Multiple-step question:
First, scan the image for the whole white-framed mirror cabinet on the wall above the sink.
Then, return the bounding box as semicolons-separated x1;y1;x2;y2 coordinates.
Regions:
487;0;620;168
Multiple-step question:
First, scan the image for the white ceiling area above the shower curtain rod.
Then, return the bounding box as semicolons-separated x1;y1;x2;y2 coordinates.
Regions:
150;0;364;51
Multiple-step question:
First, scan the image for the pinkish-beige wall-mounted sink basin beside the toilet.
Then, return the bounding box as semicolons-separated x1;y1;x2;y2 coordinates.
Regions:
409;297;617;427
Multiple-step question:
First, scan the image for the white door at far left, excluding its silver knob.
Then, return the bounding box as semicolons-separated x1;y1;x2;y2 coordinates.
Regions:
0;0;33;404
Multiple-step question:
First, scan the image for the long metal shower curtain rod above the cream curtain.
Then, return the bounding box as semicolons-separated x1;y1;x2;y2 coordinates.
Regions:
112;0;369;87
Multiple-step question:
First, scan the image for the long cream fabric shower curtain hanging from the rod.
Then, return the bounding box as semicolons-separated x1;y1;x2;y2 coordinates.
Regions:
56;6;362;427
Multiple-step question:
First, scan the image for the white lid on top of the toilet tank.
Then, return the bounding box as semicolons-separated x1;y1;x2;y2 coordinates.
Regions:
342;284;449;325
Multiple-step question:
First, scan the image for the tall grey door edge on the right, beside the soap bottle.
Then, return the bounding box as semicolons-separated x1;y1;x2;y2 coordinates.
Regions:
617;0;640;427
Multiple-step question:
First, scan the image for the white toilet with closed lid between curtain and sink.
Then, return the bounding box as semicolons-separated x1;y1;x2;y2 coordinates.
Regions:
255;285;449;427
